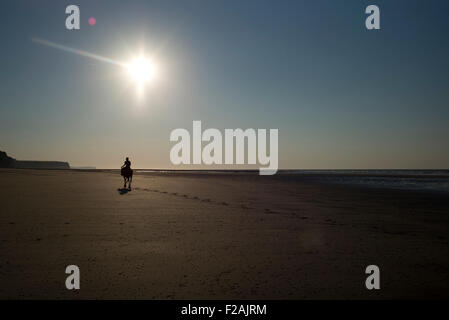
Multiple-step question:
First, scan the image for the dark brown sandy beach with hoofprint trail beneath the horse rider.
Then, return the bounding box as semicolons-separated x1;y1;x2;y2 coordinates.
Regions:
0;169;449;299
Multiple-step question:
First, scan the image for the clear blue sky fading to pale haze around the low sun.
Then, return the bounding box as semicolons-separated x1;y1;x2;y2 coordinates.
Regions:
0;0;449;168
